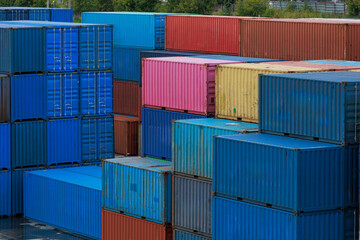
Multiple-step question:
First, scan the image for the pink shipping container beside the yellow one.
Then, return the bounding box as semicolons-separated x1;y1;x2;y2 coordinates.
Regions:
142;57;240;116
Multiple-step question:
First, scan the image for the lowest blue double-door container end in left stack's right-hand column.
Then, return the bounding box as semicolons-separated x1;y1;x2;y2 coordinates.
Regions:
81;116;114;163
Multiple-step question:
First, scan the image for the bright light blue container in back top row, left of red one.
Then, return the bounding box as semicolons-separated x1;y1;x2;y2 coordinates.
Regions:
81;12;167;49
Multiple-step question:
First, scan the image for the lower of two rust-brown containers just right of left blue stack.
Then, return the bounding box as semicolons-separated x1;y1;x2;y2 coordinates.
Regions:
114;115;139;156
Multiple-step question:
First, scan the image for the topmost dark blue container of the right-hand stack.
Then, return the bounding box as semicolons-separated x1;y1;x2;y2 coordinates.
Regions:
259;71;360;144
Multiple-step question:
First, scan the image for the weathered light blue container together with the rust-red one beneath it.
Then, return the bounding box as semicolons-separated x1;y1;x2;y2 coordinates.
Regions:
102;157;172;240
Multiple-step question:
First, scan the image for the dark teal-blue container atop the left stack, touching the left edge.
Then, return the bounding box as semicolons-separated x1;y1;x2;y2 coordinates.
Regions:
0;24;46;74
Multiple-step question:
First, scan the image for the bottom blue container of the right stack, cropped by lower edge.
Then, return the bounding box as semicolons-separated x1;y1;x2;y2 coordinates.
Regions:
213;197;358;240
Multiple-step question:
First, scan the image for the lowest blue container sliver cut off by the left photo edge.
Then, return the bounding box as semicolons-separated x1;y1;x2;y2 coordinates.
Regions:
0;171;11;217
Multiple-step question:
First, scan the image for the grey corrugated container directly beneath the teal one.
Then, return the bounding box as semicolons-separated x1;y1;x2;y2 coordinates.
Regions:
173;175;212;237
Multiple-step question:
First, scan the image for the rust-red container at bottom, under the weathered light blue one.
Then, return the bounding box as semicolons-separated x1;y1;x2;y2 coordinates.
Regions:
102;209;172;240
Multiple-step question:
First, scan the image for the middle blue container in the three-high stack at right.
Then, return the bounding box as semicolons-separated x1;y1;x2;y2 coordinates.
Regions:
214;134;359;213
